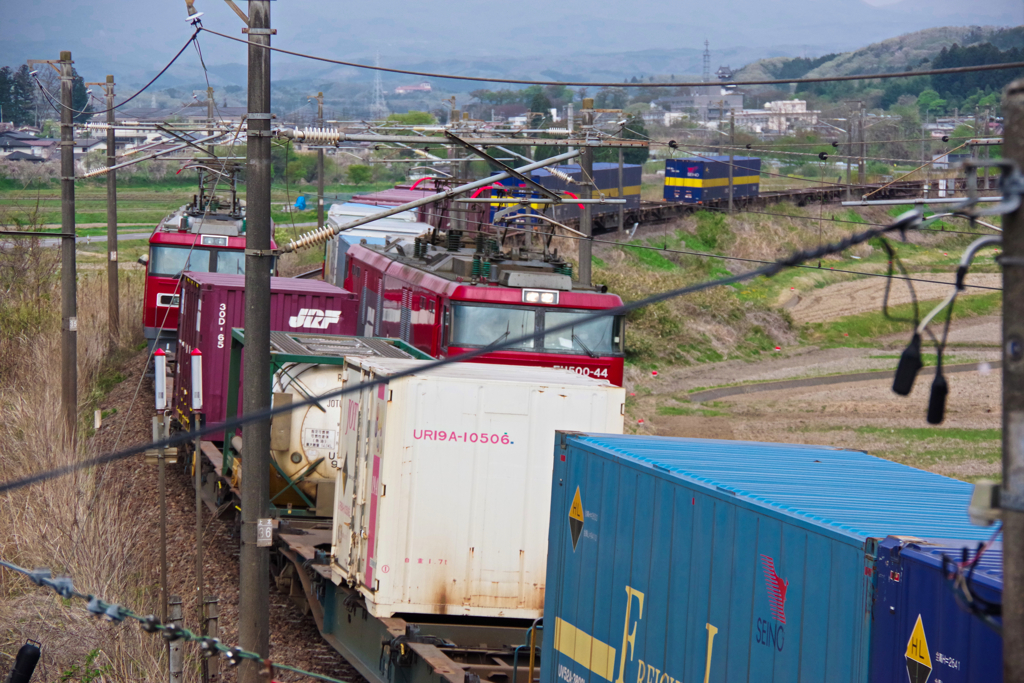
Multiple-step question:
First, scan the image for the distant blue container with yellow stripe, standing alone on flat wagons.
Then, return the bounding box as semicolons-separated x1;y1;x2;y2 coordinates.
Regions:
665;157;761;204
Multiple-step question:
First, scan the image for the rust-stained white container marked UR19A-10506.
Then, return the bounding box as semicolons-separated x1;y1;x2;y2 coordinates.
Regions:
331;358;626;618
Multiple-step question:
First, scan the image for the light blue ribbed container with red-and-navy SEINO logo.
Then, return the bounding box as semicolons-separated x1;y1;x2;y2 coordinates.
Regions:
541;432;987;683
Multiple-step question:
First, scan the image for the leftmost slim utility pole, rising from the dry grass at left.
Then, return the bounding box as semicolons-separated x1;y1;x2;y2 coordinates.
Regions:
60;52;77;449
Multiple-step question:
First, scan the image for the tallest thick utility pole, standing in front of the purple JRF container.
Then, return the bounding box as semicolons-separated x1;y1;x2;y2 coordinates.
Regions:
239;0;271;683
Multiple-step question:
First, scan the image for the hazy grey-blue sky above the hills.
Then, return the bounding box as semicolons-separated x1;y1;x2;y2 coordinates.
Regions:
0;0;1024;83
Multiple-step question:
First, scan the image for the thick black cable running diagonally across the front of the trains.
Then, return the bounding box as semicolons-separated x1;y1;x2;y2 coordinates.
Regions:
0;212;945;494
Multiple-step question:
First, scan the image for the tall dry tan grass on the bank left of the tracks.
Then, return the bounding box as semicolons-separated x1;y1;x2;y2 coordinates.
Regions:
0;236;160;681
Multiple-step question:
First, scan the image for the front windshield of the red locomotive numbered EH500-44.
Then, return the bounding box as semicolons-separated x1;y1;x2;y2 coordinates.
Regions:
452;304;623;357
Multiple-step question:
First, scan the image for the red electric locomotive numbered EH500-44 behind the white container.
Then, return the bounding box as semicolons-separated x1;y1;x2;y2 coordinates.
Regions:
344;230;625;386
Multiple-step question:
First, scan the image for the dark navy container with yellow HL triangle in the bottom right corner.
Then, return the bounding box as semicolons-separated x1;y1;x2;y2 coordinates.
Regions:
870;538;1002;683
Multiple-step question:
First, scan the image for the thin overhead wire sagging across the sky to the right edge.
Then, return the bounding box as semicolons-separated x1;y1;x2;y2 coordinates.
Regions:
201;27;1024;88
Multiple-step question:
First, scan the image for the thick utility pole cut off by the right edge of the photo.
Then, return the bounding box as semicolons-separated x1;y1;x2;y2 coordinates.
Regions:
999;80;1024;681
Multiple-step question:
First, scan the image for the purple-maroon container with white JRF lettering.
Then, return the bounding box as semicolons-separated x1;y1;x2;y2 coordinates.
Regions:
173;272;358;441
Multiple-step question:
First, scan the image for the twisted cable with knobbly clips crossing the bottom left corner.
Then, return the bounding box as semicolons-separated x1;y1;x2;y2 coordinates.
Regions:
0;560;344;683
